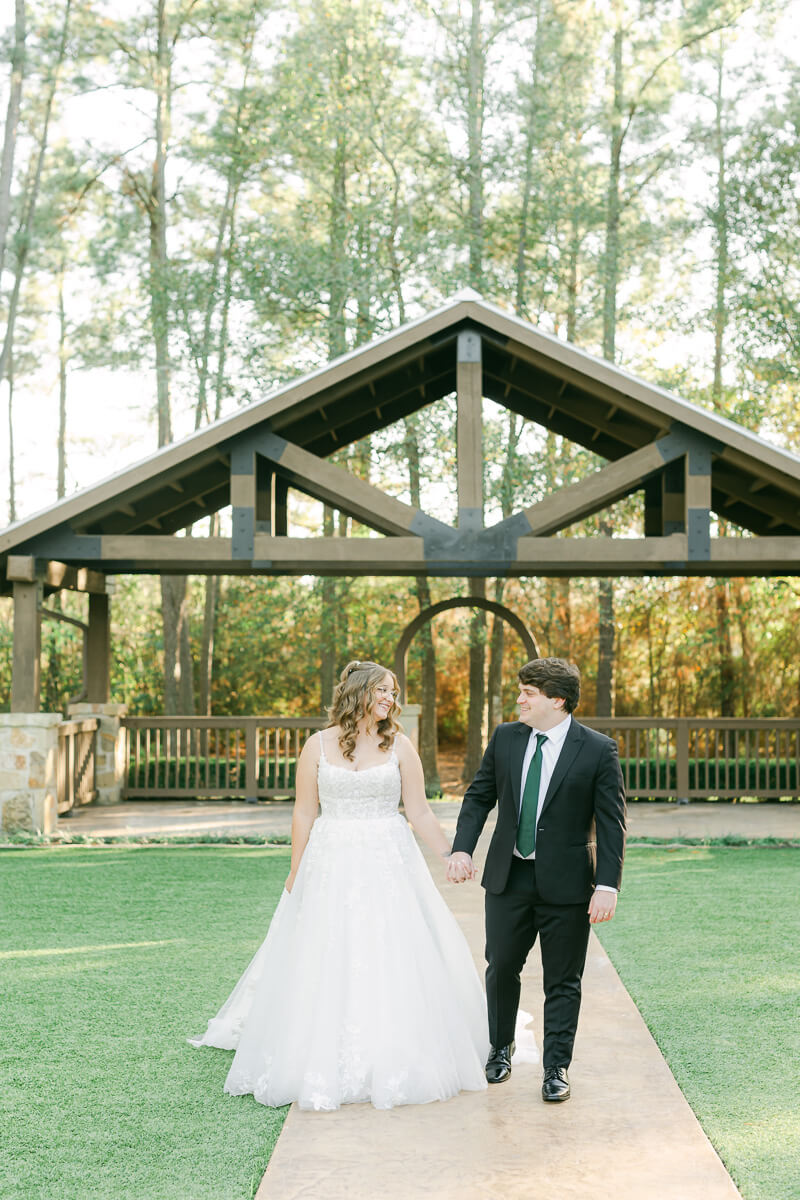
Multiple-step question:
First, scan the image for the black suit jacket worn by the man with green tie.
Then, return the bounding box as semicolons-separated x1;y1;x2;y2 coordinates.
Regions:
453;719;625;904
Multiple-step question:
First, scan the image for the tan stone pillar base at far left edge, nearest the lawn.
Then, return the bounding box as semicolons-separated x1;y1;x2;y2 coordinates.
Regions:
0;713;64;836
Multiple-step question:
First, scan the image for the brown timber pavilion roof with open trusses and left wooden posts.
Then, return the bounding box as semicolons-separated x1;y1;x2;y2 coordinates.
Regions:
0;293;800;713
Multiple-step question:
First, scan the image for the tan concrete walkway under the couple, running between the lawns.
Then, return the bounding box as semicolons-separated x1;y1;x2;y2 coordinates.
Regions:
257;844;739;1200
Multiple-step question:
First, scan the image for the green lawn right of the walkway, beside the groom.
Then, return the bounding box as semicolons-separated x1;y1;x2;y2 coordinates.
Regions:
600;847;800;1200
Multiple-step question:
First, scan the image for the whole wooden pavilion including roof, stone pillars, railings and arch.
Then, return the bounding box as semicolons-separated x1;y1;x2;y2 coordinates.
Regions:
0;293;800;833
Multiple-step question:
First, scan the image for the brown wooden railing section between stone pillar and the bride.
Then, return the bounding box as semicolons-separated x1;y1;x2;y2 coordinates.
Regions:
122;716;326;800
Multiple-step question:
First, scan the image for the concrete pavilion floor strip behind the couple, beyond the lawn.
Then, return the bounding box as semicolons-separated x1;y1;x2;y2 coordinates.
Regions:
59;800;800;841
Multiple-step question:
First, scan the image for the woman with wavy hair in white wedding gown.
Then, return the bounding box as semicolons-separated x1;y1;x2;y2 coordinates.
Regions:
191;661;488;1109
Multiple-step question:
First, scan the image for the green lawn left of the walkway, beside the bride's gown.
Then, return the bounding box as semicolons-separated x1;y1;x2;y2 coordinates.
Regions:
0;846;288;1200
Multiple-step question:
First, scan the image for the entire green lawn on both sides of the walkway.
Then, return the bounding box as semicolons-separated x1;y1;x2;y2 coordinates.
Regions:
0;846;800;1200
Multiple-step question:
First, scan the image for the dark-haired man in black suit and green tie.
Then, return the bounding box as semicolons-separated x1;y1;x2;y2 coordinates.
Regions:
447;659;625;1100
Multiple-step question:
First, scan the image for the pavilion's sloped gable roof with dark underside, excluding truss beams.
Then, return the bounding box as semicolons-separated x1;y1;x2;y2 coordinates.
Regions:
0;292;800;578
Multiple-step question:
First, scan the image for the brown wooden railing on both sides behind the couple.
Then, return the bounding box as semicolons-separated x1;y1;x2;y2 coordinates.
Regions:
117;716;800;800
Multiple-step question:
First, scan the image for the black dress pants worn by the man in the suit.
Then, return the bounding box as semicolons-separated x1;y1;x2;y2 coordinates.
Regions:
486;857;589;1067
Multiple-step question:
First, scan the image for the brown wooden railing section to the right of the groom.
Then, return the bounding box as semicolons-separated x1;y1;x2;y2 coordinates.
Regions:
584;716;800;800
